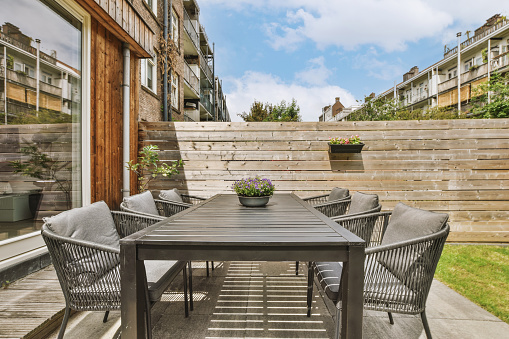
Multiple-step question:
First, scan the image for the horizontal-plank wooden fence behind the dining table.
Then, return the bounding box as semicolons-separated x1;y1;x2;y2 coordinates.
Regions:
139;119;509;242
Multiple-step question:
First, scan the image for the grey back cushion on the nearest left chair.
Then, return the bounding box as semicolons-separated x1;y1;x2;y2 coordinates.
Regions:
43;201;120;249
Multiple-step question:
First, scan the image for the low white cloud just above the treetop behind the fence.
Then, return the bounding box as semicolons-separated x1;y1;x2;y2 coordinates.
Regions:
224;71;356;121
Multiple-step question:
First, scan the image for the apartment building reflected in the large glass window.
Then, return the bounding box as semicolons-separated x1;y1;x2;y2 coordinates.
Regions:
0;22;81;124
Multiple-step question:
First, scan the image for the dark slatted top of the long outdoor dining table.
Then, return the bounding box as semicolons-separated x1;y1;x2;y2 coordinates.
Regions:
121;194;363;247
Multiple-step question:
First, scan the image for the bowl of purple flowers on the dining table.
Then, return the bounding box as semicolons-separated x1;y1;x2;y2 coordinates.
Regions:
232;177;276;207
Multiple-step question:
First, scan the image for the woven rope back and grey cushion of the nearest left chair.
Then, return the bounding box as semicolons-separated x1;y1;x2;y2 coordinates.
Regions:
41;202;120;310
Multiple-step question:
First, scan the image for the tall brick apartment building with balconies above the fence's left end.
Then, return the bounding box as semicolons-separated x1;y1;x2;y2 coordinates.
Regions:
140;0;229;121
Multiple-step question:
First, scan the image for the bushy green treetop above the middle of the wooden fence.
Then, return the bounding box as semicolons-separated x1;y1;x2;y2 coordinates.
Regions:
238;99;302;122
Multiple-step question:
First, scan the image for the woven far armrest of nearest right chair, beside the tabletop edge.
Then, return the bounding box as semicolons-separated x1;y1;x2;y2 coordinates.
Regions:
331;211;392;247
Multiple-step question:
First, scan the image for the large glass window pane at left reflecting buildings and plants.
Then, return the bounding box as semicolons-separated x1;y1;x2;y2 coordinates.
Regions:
0;0;82;243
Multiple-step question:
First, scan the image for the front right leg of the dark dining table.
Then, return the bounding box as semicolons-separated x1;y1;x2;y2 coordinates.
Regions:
336;246;365;339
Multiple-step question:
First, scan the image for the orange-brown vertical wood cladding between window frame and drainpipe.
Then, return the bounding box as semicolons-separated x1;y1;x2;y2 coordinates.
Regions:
90;20;123;209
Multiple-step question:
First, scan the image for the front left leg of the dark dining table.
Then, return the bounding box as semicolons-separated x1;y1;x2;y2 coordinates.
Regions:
120;243;150;339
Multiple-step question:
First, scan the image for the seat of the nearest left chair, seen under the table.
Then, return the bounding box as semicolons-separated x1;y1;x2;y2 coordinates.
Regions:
145;260;186;301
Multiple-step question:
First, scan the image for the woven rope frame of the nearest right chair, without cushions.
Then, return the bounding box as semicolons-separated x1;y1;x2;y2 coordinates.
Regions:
308;212;450;339
